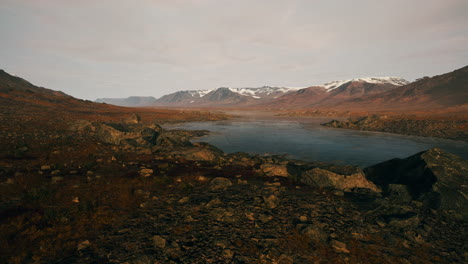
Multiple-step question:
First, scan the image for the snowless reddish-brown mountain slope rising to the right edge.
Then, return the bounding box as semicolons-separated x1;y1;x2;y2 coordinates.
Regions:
335;66;468;112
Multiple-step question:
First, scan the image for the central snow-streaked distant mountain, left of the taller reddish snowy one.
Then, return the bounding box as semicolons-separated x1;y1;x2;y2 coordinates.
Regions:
155;86;296;107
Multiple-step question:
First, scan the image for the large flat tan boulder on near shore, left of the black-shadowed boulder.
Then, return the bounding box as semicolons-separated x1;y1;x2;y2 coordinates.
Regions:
299;168;380;192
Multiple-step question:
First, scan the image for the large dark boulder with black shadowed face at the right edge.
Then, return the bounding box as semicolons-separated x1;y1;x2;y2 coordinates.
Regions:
364;148;468;219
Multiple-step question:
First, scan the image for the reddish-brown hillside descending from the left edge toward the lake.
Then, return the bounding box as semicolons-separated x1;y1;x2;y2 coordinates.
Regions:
0;70;229;124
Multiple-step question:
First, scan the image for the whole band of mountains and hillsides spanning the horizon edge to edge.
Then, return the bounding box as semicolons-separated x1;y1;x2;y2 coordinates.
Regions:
0;66;468;113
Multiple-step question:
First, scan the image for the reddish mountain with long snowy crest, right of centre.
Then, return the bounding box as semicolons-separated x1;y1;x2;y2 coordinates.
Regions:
259;77;409;109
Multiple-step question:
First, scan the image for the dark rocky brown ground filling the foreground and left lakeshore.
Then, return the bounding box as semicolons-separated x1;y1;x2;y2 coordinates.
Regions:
0;69;468;264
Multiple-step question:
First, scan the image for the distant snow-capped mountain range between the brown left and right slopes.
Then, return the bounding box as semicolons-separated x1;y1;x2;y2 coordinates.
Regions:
96;77;409;108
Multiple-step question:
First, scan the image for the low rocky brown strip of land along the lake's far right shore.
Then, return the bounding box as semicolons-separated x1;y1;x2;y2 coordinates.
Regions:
322;115;468;141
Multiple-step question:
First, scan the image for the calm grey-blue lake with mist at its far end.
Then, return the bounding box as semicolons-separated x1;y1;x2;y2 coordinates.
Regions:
164;116;468;167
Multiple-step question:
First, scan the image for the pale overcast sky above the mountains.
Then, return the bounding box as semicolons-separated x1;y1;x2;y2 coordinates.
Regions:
0;0;468;100
